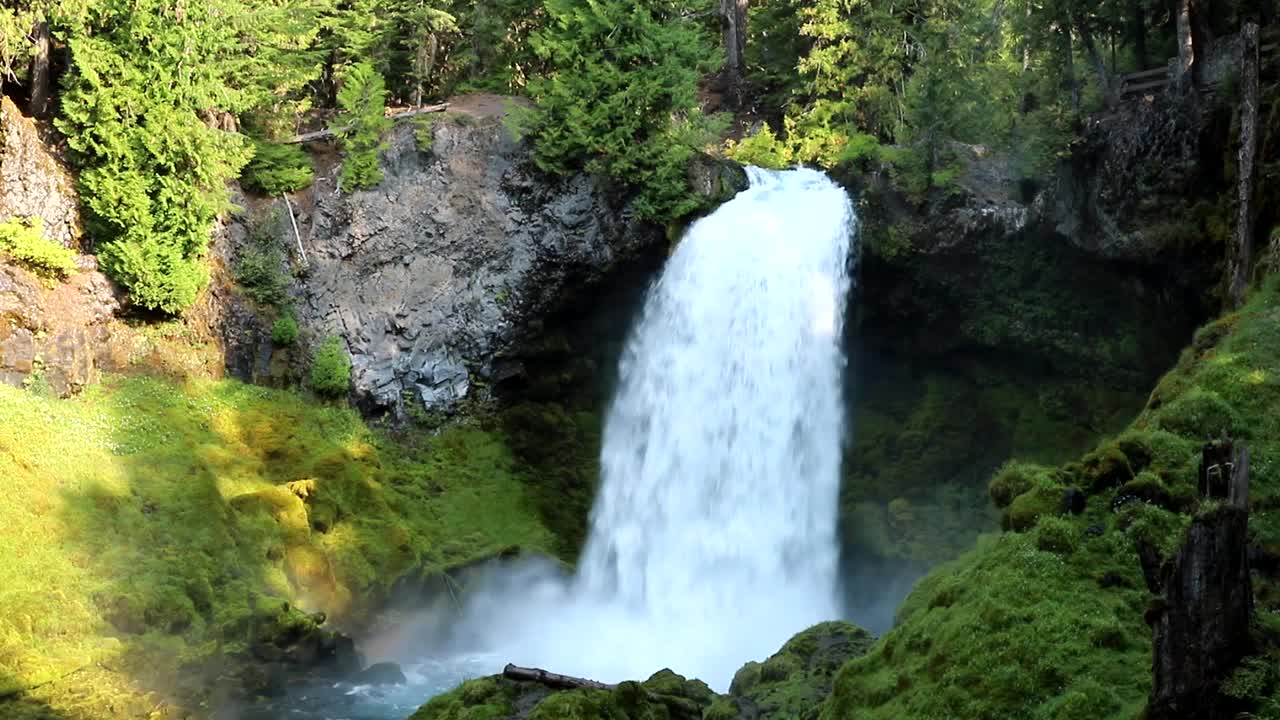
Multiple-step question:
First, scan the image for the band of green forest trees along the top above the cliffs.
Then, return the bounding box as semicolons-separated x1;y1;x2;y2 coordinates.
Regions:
0;0;1257;313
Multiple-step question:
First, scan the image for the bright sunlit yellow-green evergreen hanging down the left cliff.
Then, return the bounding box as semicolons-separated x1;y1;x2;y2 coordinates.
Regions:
58;0;259;313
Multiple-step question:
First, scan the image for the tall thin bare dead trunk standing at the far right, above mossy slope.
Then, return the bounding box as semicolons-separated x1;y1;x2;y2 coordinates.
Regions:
1228;23;1258;307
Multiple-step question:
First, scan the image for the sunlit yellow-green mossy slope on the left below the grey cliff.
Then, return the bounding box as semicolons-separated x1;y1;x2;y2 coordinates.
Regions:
0;378;554;717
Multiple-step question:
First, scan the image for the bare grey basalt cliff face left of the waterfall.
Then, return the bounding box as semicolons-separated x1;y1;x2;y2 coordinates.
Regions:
260;114;666;415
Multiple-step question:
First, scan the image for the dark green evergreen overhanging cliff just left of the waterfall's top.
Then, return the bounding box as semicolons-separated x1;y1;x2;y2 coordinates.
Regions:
527;0;716;219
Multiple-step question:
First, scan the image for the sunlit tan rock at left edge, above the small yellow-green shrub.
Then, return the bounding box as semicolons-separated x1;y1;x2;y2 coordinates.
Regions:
0;97;82;247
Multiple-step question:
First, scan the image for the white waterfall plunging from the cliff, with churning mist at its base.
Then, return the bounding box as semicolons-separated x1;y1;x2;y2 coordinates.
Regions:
455;168;854;691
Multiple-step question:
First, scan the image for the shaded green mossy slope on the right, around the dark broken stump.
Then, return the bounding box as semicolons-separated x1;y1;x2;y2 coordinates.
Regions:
823;278;1280;720
